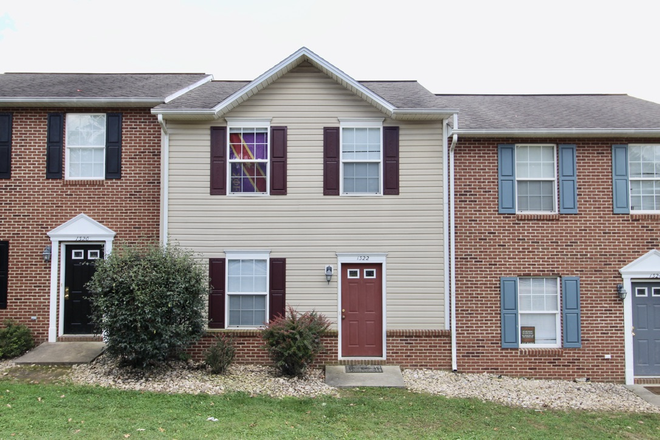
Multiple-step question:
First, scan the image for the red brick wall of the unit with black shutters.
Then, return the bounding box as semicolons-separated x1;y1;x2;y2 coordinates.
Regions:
0;108;160;341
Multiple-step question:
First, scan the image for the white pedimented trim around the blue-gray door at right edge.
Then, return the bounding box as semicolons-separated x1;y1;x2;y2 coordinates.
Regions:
612;249;660;385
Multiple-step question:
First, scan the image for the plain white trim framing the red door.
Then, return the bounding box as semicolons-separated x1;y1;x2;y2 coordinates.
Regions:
336;252;387;360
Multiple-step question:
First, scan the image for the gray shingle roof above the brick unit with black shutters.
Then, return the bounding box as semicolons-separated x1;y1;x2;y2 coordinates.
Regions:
0;73;209;101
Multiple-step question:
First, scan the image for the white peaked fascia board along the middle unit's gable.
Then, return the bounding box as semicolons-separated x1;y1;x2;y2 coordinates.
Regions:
213;47;396;117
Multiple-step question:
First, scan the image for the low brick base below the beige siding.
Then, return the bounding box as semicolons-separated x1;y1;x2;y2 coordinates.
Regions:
189;330;451;369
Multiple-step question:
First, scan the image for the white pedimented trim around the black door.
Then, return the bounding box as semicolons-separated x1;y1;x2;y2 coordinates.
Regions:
48;214;116;342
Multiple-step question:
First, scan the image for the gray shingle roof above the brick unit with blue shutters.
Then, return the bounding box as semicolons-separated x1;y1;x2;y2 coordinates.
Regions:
436;95;660;131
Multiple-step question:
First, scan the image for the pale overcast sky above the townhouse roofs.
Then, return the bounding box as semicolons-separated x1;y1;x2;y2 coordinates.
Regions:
0;0;660;103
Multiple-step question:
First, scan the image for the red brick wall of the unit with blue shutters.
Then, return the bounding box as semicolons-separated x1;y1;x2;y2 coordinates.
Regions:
455;139;660;382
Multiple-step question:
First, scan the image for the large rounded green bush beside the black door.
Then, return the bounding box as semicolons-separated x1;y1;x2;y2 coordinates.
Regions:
87;245;209;367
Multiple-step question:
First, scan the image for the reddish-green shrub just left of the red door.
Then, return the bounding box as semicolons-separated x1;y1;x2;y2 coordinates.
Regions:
261;307;330;377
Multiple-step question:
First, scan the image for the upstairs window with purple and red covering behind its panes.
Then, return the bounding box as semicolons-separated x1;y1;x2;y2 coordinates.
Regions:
229;127;269;194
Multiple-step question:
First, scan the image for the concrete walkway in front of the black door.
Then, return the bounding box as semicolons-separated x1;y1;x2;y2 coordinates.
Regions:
14;342;105;365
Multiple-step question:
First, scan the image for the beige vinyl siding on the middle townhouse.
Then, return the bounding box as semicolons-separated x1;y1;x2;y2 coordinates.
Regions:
168;63;445;329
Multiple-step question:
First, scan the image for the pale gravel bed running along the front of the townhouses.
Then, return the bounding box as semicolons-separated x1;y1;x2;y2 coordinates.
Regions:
0;356;660;413
